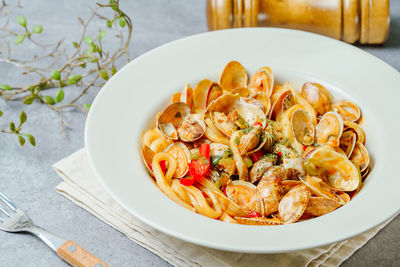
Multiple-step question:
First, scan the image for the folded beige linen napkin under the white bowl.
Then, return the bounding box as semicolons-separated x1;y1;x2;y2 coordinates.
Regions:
53;149;396;266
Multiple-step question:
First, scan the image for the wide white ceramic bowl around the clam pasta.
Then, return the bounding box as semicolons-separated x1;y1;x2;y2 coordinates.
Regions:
85;28;400;253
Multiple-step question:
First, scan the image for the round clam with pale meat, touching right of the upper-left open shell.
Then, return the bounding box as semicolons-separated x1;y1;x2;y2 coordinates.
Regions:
178;114;206;142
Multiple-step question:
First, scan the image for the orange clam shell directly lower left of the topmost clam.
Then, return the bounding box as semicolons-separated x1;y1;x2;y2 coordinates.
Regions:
192;79;222;113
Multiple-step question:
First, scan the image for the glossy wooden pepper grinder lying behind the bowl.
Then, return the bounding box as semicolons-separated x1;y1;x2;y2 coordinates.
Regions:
207;0;390;44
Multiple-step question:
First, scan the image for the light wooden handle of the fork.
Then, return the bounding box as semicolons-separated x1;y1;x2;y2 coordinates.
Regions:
57;240;110;267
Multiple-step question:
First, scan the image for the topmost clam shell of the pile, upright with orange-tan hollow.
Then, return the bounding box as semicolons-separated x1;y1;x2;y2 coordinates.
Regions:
220;61;249;91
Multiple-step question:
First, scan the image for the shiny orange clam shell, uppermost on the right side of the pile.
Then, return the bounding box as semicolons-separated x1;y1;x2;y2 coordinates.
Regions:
301;82;330;115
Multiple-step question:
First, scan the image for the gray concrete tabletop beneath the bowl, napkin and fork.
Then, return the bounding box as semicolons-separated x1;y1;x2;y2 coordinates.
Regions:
0;0;400;266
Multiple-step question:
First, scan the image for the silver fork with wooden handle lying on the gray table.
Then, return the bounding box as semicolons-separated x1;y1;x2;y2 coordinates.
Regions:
0;192;110;267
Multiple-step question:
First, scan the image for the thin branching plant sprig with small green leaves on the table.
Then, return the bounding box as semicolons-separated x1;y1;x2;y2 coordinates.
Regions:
0;0;133;145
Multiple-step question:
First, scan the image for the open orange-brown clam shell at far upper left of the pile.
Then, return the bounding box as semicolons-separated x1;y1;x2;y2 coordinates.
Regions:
157;102;190;140
